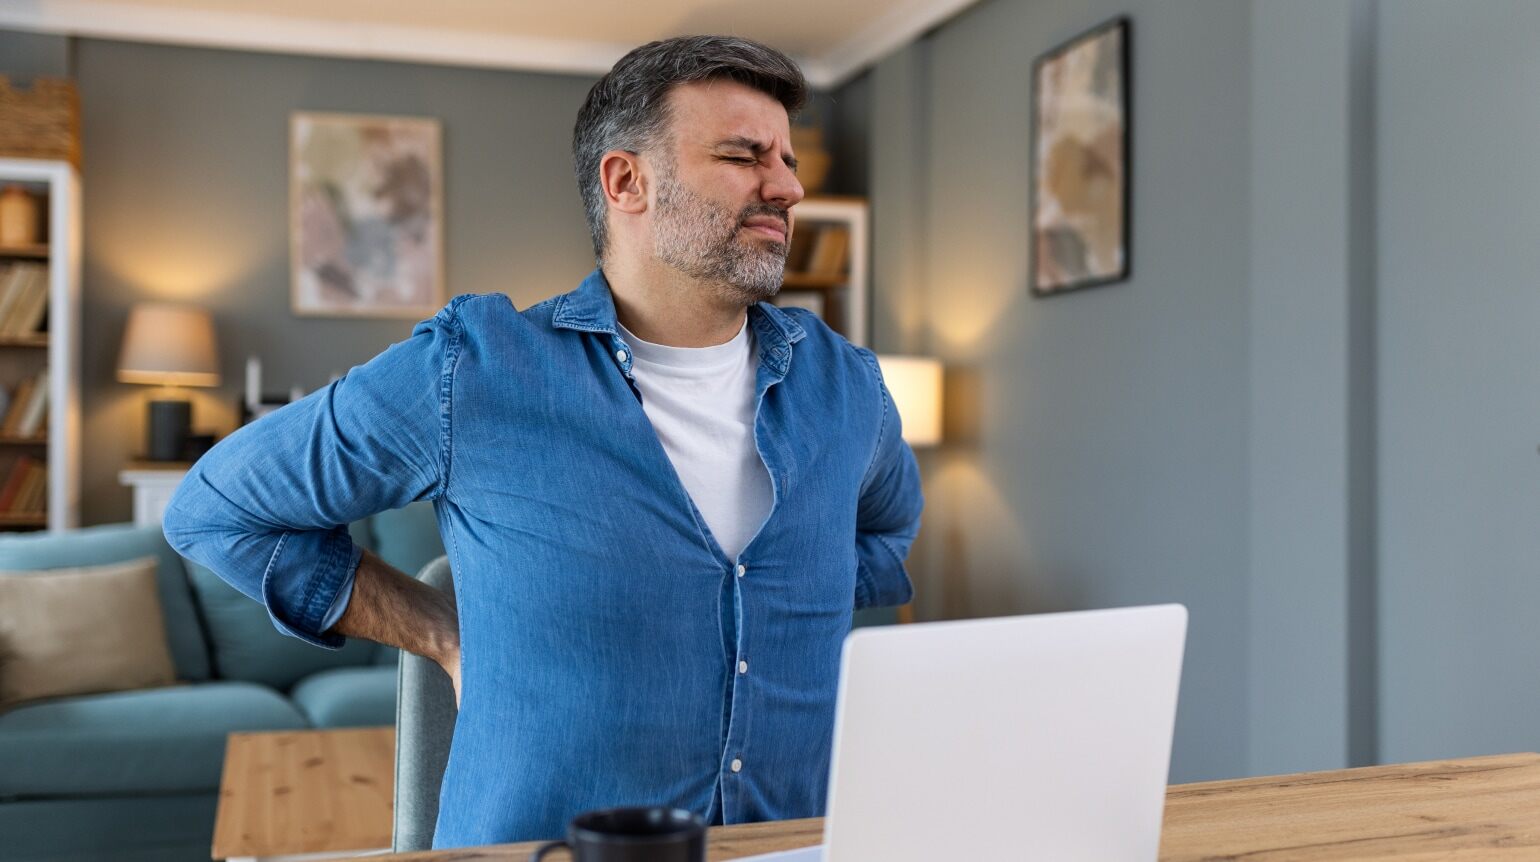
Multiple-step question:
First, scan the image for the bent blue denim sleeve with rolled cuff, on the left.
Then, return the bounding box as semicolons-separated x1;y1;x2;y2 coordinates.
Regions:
162;300;462;648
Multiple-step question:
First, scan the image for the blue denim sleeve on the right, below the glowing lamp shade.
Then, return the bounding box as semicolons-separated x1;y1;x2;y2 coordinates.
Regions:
855;349;924;610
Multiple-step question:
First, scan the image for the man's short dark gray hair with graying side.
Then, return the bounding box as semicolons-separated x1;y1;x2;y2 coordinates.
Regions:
573;35;807;262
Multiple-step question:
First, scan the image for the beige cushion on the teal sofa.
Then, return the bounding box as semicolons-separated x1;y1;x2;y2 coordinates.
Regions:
0;557;176;708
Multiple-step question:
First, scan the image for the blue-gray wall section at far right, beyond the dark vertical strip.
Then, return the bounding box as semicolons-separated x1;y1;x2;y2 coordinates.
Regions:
1377;0;1540;760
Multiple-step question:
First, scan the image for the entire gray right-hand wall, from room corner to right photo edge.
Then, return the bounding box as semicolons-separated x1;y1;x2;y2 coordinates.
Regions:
836;0;1540;780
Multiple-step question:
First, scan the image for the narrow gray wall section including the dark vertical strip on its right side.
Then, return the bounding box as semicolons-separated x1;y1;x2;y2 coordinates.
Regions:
1247;0;1375;773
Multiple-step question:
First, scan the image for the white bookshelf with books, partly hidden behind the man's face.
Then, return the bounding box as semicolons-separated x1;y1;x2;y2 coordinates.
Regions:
773;195;869;346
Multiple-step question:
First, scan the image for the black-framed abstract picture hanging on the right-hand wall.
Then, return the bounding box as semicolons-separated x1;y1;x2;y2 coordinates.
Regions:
1032;18;1130;296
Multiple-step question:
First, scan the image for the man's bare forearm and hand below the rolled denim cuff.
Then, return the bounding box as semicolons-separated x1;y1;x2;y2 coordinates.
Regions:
333;550;460;707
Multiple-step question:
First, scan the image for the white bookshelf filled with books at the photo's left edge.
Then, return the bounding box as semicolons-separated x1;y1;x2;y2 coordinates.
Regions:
0;159;80;531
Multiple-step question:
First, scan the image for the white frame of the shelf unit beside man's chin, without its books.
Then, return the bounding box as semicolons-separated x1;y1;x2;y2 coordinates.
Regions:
778;195;869;346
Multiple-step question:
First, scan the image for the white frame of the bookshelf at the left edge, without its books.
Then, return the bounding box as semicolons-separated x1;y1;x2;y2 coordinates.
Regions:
0;159;82;531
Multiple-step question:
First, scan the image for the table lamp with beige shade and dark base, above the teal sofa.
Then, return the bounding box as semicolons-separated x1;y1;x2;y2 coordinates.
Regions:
117;302;219;460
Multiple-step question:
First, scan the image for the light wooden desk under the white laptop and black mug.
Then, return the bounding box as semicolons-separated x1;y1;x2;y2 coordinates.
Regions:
343;754;1540;862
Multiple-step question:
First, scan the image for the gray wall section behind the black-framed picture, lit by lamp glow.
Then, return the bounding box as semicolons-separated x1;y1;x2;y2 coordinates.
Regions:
850;0;1250;780
